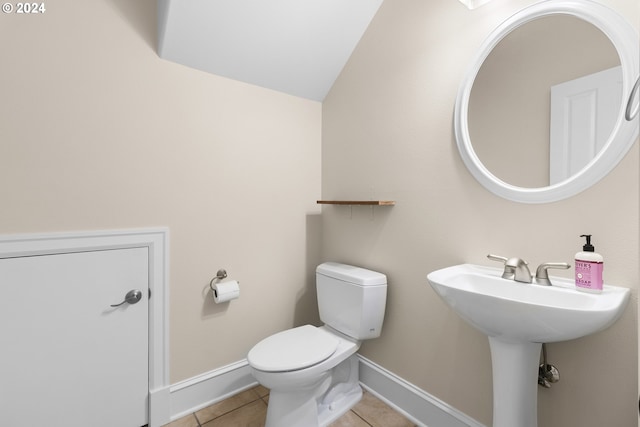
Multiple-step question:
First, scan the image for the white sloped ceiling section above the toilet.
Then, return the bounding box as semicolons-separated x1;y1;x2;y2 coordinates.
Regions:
158;0;383;101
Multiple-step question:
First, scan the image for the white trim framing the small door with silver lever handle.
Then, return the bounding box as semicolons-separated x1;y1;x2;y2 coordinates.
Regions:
0;228;171;427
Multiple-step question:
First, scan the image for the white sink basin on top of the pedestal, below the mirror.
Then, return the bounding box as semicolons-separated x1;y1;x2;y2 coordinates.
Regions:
427;264;630;343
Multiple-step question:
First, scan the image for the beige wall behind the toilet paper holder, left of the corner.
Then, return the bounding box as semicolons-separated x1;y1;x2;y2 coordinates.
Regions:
0;0;321;382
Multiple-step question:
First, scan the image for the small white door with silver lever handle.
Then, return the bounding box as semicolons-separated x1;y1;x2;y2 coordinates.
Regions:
0;247;149;427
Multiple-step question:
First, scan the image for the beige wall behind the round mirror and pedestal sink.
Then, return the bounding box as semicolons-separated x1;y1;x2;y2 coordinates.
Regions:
322;0;640;427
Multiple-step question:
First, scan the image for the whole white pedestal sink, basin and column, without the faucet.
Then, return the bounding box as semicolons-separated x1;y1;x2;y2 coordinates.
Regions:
427;264;630;427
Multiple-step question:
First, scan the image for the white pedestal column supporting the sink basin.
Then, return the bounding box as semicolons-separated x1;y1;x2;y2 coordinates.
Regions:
489;337;542;427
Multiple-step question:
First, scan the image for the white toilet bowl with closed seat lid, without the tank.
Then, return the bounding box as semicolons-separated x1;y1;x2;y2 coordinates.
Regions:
247;325;362;427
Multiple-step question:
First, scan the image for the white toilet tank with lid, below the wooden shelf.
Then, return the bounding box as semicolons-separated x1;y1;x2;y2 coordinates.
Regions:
316;262;387;340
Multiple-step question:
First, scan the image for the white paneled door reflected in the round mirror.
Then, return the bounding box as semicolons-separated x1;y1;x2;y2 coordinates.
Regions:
549;67;622;184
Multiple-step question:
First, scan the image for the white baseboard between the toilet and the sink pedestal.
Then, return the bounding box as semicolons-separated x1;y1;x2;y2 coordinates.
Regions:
358;355;485;427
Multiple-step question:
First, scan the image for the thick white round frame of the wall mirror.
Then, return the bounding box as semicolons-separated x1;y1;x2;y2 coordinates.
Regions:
454;0;640;203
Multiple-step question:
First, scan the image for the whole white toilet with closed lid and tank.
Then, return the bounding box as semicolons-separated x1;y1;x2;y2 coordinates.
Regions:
247;262;387;427
